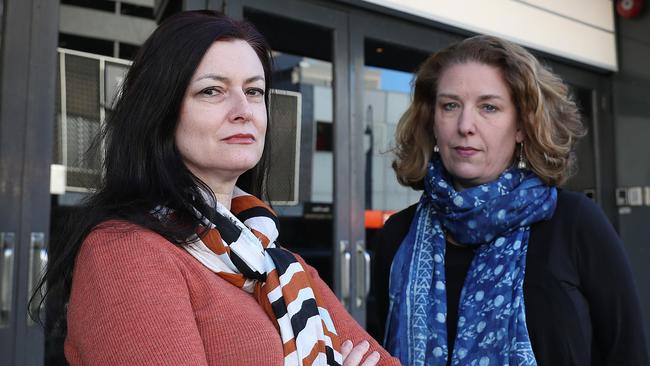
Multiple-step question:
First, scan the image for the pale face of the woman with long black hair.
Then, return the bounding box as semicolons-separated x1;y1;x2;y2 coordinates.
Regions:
175;40;267;190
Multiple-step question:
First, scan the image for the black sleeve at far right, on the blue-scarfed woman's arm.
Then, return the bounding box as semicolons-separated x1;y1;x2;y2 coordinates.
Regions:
573;198;649;365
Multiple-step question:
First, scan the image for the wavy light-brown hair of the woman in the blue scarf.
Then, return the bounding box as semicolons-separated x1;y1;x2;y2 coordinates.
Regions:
393;36;586;189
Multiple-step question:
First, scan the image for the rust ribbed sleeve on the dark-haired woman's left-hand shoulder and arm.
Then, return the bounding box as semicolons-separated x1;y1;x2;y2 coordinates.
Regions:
66;228;207;365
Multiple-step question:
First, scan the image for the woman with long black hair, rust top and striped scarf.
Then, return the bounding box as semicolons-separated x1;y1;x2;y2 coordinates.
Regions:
36;11;398;365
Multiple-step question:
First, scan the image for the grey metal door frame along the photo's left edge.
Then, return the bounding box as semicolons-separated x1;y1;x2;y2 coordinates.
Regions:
0;0;59;365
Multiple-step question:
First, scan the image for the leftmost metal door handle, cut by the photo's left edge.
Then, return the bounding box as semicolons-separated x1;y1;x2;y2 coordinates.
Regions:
0;232;16;327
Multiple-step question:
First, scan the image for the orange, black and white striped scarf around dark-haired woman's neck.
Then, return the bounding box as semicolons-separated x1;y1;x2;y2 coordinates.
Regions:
185;188;343;366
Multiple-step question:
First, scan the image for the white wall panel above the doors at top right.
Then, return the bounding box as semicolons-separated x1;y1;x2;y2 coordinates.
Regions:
364;0;618;71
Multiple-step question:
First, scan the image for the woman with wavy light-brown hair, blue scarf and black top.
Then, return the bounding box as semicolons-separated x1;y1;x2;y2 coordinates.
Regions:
374;36;648;366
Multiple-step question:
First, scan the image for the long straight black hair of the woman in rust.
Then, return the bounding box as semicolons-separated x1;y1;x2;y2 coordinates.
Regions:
30;11;271;332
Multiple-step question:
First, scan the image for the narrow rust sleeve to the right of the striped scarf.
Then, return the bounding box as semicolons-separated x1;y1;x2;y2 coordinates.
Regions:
298;257;400;366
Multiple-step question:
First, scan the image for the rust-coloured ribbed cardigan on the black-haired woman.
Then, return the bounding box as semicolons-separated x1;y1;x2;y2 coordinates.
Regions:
65;221;399;366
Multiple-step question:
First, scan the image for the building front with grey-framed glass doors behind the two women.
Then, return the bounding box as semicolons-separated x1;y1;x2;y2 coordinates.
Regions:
0;0;650;365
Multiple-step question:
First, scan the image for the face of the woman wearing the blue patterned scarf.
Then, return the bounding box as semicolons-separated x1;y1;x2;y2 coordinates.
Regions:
433;62;523;190
